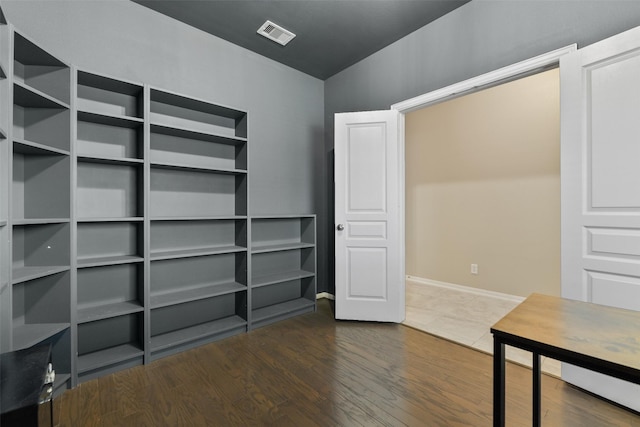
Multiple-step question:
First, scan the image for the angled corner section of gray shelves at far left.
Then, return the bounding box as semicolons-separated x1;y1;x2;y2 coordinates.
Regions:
0;24;72;391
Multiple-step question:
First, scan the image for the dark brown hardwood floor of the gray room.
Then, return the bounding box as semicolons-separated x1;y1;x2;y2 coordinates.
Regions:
55;300;640;427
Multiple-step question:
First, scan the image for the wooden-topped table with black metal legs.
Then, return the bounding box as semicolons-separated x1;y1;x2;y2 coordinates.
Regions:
491;294;640;426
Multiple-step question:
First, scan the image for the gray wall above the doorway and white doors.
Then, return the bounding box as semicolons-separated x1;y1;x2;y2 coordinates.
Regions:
321;0;640;292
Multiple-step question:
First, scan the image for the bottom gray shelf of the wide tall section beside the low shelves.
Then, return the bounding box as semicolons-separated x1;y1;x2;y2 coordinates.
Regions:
151;315;247;353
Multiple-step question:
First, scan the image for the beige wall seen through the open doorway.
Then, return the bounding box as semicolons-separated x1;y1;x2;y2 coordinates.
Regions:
406;69;560;296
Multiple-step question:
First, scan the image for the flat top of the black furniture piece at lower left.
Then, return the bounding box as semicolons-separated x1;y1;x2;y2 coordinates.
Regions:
0;345;51;414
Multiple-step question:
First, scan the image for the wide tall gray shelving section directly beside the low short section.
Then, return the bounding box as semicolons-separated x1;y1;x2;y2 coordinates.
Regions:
149;89;248;359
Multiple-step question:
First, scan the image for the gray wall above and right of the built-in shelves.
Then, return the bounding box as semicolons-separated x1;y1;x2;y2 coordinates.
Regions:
3;0;325;289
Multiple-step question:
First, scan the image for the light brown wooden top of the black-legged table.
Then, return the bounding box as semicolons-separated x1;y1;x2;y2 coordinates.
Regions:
491;294;640;377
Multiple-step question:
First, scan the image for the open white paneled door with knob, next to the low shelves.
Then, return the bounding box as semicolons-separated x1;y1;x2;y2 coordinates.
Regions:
334;110;405;322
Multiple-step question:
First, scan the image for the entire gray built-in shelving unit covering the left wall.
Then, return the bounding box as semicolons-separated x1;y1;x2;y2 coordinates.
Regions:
0;9;316;390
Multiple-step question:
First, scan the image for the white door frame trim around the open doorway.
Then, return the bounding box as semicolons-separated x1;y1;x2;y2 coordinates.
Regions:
390;43;578;294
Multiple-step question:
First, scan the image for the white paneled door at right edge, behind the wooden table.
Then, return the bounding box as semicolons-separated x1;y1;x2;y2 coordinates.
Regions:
560;23;640;411
